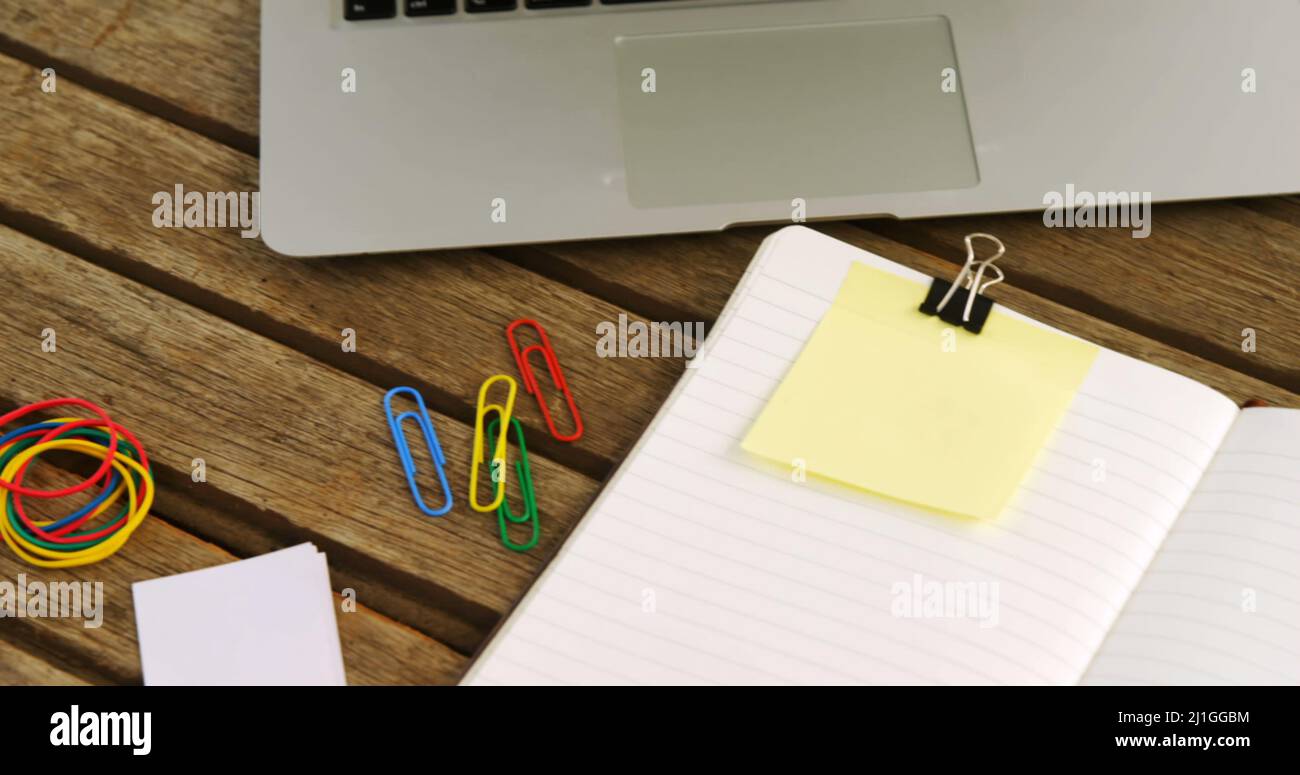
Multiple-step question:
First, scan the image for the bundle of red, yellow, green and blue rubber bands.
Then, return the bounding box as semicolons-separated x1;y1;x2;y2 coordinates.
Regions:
0;398;153;568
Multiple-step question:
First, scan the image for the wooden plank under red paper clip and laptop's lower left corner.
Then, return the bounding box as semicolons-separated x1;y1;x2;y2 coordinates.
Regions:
0;57;681;477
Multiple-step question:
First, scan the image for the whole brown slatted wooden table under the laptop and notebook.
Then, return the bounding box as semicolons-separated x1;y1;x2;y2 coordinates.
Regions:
0;0;1300;683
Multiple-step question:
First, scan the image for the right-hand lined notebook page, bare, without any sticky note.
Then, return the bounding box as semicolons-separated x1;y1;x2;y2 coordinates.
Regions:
1086;408;1300;684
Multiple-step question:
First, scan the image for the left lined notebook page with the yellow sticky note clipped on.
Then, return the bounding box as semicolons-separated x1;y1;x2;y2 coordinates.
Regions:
465;226;1238;684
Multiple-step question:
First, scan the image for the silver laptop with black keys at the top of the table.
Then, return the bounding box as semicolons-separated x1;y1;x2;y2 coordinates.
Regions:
261;0;1300;256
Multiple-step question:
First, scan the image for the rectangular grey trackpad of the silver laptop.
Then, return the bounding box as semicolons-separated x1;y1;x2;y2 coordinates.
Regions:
615;17;979;207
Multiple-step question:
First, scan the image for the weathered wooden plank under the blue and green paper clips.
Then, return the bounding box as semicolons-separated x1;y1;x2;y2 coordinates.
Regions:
0;229;597;651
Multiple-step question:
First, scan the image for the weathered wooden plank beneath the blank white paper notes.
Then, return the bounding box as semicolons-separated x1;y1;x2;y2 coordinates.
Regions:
0;466;467;684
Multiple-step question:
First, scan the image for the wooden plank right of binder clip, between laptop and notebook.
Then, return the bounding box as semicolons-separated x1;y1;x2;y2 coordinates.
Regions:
863;200;1300;391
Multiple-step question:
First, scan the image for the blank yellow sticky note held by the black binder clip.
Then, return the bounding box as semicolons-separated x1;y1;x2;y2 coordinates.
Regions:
741;264;1097;519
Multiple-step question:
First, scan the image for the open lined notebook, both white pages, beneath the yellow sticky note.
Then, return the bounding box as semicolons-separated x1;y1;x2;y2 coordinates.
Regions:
464;226;1300;684
